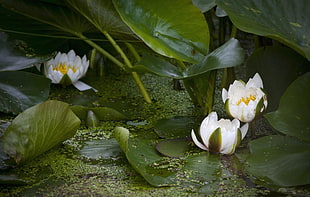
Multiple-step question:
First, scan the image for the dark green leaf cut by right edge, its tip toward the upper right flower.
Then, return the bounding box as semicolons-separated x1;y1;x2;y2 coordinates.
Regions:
265;72;310;142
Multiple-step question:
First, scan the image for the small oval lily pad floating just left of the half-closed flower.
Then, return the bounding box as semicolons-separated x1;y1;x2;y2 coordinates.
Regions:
156;138;192;157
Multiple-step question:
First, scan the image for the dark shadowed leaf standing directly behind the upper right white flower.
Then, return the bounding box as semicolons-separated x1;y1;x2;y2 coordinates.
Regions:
246;46;310;112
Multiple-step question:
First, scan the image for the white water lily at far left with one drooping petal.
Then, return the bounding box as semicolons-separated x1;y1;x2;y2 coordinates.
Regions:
44;50;96;91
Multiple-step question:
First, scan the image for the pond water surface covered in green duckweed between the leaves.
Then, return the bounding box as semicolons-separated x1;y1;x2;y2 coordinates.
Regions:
0;69;310;196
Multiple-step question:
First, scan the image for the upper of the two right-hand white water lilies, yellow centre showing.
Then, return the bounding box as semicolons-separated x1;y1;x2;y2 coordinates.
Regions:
222;73;268;122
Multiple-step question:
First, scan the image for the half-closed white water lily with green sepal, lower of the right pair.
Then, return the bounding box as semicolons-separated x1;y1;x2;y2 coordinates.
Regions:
192;112;249;154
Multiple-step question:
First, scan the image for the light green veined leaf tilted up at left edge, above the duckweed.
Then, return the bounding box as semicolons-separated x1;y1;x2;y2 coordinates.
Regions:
1;100;81;164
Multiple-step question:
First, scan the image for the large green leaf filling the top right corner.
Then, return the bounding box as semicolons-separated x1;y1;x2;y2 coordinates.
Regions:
216;0;310;60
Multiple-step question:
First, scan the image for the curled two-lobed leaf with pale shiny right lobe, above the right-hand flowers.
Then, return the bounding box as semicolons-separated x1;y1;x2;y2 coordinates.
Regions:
134;38;244;79
